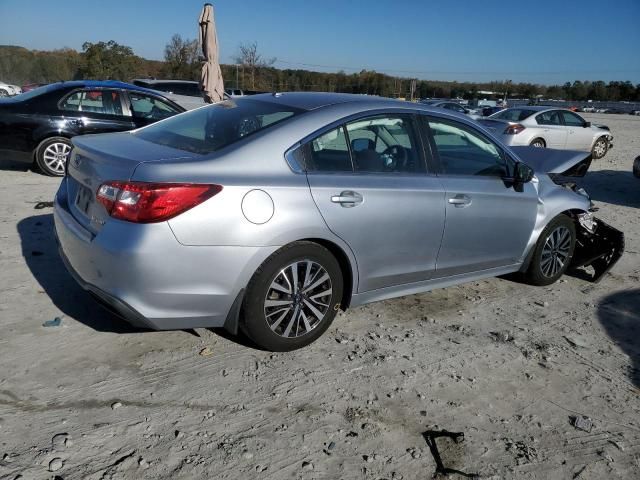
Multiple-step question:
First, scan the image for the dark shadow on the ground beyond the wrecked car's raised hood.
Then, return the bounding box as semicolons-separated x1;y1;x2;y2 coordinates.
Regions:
576;169;640;208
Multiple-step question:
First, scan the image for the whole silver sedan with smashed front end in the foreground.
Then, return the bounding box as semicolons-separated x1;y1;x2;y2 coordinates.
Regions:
54;93;623;351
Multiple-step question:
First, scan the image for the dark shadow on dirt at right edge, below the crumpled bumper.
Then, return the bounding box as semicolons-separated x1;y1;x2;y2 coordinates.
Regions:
598;288;640;388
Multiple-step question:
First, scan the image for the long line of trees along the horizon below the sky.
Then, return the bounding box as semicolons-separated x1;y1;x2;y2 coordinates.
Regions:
0;39;640;101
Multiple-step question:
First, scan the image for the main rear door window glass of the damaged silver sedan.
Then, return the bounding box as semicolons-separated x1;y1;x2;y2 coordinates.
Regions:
346;116;423;173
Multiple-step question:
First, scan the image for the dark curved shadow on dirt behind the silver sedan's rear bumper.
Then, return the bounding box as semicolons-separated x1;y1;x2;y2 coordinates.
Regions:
18;213;145;333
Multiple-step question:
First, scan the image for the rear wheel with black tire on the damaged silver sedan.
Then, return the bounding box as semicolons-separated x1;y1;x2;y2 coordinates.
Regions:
240;241;343;352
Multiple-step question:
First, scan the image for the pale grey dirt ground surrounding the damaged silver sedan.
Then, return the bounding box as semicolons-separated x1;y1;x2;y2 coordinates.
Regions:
0;115;640;480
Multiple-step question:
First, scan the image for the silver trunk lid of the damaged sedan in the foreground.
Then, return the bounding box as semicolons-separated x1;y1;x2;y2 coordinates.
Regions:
63;132;197;234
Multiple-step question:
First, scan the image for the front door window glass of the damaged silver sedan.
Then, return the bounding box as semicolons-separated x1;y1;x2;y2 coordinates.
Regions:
429;119;507;177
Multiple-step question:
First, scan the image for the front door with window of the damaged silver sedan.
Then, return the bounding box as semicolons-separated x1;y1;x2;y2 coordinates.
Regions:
424;116;538;277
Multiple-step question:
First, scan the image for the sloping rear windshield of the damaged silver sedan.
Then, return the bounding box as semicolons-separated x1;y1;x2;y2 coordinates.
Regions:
133;99;303;154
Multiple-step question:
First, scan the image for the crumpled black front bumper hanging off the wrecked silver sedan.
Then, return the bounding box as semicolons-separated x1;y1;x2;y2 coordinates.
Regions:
571;218;624;283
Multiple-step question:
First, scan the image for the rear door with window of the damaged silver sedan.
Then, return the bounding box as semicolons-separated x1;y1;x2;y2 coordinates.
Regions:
305;114;445;293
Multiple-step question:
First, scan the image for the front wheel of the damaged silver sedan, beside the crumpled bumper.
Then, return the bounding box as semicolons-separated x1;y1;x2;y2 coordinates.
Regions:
525;214;576;286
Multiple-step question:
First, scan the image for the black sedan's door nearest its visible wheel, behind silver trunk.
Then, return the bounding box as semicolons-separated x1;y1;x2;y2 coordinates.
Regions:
58;88;134;135
